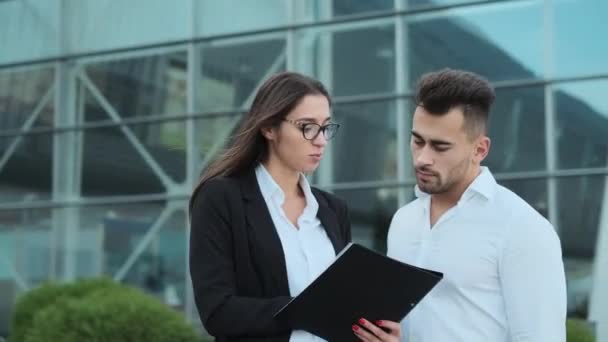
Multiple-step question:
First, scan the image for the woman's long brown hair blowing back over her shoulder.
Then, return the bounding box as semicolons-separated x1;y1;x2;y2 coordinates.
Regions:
190;72;331;209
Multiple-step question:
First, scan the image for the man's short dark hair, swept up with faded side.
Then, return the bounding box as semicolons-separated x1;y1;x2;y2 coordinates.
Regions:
416;69;496;137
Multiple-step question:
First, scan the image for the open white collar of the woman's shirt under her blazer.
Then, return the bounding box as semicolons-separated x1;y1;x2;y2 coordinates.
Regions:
255;164;319;217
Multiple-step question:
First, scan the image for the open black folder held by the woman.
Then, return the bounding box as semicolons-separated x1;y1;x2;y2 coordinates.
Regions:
275;243;443;342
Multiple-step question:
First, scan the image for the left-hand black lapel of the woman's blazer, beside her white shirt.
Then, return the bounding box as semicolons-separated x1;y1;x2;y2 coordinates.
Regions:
241;171;289;295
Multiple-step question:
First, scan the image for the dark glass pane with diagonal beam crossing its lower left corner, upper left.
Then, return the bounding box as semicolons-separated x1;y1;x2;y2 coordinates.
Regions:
80;52;187;121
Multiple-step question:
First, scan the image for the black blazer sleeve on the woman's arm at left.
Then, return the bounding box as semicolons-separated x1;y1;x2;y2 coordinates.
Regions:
189;180;291;336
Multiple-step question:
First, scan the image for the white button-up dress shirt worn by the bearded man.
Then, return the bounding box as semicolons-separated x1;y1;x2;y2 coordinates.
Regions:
388;167;566;342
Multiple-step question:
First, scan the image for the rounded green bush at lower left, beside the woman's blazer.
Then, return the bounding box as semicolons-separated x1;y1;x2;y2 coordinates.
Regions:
10;279;201;342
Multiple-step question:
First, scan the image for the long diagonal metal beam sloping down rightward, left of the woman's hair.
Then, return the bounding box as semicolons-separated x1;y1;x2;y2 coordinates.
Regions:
78;70;176;190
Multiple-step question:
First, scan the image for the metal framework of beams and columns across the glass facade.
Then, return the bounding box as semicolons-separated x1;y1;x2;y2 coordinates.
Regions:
0;0;608;336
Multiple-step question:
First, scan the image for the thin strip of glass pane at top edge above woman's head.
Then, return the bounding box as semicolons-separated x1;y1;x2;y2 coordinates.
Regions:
294;0;395;21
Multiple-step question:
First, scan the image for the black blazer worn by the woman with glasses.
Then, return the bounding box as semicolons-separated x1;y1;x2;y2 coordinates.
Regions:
190;170;351;342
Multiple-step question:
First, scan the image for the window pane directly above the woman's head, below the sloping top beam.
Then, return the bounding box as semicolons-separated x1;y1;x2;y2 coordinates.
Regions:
295;20;395;96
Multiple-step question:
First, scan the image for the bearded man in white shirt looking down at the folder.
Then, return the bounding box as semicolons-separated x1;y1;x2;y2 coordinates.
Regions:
388;69;566;342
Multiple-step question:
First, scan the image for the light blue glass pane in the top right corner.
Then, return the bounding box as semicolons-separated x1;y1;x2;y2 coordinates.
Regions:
553;0;608;77
